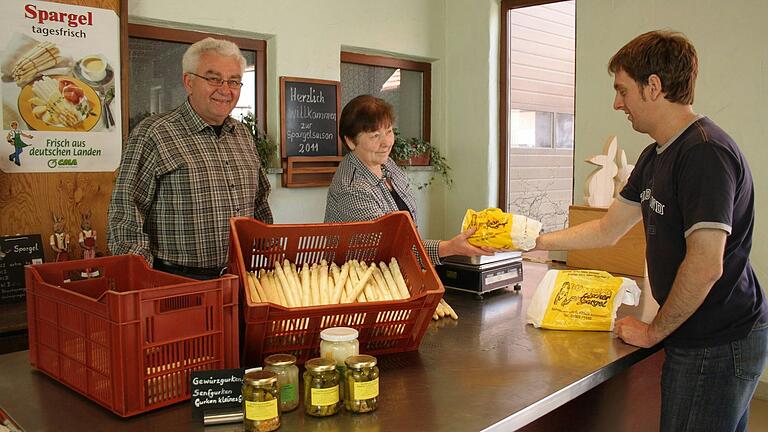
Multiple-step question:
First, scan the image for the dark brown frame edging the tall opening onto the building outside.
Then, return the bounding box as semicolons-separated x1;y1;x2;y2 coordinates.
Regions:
497;0;575;209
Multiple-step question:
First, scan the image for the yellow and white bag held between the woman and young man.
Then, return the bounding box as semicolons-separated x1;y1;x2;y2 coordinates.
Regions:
461;208;541;250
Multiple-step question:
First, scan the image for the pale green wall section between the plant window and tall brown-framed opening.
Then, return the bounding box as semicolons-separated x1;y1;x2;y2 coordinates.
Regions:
440;0;499;234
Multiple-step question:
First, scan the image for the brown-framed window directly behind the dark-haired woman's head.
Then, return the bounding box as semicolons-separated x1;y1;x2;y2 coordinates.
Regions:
341;52;432;141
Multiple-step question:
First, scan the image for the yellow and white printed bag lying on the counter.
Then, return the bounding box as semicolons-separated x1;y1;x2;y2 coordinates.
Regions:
528;270;640;331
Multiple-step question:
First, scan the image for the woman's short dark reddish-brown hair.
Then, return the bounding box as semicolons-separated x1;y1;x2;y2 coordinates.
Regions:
339;95;395;143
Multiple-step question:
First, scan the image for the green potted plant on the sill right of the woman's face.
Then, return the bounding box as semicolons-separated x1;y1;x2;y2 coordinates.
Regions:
391;128;453;189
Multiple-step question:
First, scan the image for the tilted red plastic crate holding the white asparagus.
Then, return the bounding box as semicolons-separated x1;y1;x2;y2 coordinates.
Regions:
229;212;445;366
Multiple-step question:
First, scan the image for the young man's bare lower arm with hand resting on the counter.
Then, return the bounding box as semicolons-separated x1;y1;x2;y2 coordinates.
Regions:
614;228;728;348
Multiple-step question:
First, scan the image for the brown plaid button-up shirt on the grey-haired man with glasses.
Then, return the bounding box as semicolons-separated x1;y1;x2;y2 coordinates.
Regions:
108;101;272;268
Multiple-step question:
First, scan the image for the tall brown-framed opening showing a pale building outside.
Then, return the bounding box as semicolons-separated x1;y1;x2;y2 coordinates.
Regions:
499;0;576;231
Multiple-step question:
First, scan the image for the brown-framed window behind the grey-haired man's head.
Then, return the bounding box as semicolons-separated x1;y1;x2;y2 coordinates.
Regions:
128;24;266;130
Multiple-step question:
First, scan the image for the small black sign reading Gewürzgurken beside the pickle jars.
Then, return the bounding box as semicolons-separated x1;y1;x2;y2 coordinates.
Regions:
189;368;245;419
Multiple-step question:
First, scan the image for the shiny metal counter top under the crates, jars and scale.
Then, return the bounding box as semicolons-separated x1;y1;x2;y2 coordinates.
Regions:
0;262;658;432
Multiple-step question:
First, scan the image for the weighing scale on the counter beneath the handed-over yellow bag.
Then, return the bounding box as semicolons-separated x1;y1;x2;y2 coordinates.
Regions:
436;252;523;297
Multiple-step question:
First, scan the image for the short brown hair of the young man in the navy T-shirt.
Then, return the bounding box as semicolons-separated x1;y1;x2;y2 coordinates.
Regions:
608;30;699;105
